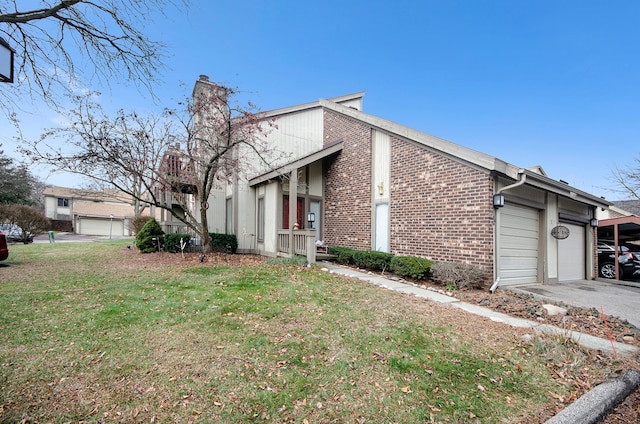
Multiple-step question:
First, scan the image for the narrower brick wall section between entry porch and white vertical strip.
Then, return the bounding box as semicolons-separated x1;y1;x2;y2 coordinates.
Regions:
324;110;371;250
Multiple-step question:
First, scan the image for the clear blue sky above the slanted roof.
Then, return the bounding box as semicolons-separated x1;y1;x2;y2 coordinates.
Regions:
0;0;640;200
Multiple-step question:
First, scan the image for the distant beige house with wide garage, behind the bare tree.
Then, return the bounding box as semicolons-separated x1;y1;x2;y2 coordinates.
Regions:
44;187;155;237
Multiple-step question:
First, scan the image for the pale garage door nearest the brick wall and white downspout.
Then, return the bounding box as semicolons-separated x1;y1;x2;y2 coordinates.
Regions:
499;204;540;285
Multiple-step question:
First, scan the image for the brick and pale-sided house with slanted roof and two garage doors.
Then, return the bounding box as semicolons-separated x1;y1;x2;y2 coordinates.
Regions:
194;77;610;285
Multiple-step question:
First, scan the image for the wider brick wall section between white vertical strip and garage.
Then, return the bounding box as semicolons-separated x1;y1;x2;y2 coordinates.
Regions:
389;138;494;270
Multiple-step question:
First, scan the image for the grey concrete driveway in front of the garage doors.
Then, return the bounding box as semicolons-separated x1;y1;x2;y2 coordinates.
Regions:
510;280;640;328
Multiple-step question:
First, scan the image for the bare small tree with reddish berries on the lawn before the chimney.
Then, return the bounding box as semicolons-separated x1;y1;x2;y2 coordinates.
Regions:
20;83;275;252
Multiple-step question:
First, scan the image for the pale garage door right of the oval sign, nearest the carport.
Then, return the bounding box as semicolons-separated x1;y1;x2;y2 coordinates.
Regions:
558;223;586;282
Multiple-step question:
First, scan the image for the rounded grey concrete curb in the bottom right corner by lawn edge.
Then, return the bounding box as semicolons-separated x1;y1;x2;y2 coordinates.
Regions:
545;370;640;424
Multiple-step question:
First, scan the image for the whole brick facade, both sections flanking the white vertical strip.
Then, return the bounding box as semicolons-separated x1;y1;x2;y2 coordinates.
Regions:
324;110;494;275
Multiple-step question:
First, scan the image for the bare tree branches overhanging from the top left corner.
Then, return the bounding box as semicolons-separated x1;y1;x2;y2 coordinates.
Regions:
0;0;189;114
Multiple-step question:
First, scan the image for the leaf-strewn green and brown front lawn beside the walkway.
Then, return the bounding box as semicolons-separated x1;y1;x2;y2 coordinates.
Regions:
0;241;568;423
